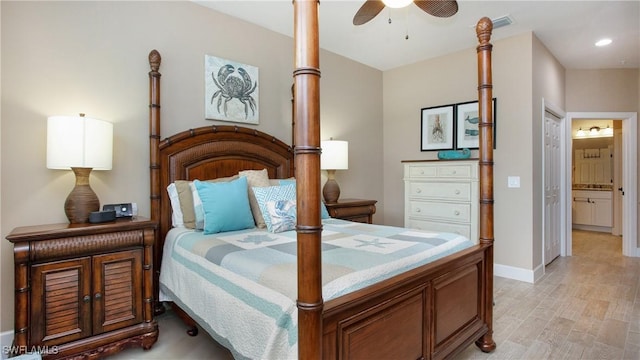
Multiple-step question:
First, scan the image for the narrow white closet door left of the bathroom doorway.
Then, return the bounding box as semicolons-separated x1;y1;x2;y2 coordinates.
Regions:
544;112;561;265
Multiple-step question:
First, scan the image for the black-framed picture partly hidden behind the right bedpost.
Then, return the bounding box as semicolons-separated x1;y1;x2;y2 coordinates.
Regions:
456;98;496;149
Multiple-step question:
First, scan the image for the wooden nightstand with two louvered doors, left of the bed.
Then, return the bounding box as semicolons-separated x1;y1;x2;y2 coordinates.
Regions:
7;217;158;358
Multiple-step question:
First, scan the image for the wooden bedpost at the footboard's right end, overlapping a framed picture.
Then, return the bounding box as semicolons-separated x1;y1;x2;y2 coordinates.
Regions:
476;17;496;352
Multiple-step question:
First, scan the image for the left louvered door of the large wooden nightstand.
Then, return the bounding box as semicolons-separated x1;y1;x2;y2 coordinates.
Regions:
31;257;91;346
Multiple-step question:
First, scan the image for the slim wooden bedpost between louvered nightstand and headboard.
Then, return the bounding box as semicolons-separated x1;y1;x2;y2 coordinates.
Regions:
149;50;164;314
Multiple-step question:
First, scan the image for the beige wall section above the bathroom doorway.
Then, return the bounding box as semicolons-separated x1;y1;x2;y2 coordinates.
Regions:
566;69;640;248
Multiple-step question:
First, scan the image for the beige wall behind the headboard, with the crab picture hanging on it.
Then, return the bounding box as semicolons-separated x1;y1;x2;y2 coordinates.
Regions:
0;1;382;331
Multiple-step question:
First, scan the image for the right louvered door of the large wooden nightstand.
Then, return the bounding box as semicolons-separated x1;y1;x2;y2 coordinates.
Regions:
93;249;142;334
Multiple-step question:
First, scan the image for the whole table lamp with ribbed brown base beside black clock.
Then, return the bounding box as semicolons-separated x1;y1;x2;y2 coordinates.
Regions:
47;114;113;224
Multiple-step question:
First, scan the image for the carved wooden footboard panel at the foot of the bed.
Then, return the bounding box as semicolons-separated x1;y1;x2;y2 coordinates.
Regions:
322;245;489;360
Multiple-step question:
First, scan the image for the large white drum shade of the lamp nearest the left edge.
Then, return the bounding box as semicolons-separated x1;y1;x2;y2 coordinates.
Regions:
47;114;113;170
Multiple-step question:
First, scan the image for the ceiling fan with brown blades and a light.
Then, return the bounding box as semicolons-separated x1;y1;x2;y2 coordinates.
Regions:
353;0;458;25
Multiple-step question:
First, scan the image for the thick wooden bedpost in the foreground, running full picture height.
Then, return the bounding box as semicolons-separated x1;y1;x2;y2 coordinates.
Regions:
293;0;323;359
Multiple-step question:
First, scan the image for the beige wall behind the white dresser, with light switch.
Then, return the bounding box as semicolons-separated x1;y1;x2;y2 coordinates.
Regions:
383;33;533;276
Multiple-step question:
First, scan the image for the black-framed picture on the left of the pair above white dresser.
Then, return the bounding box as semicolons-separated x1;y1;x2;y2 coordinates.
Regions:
420;105;454;151
